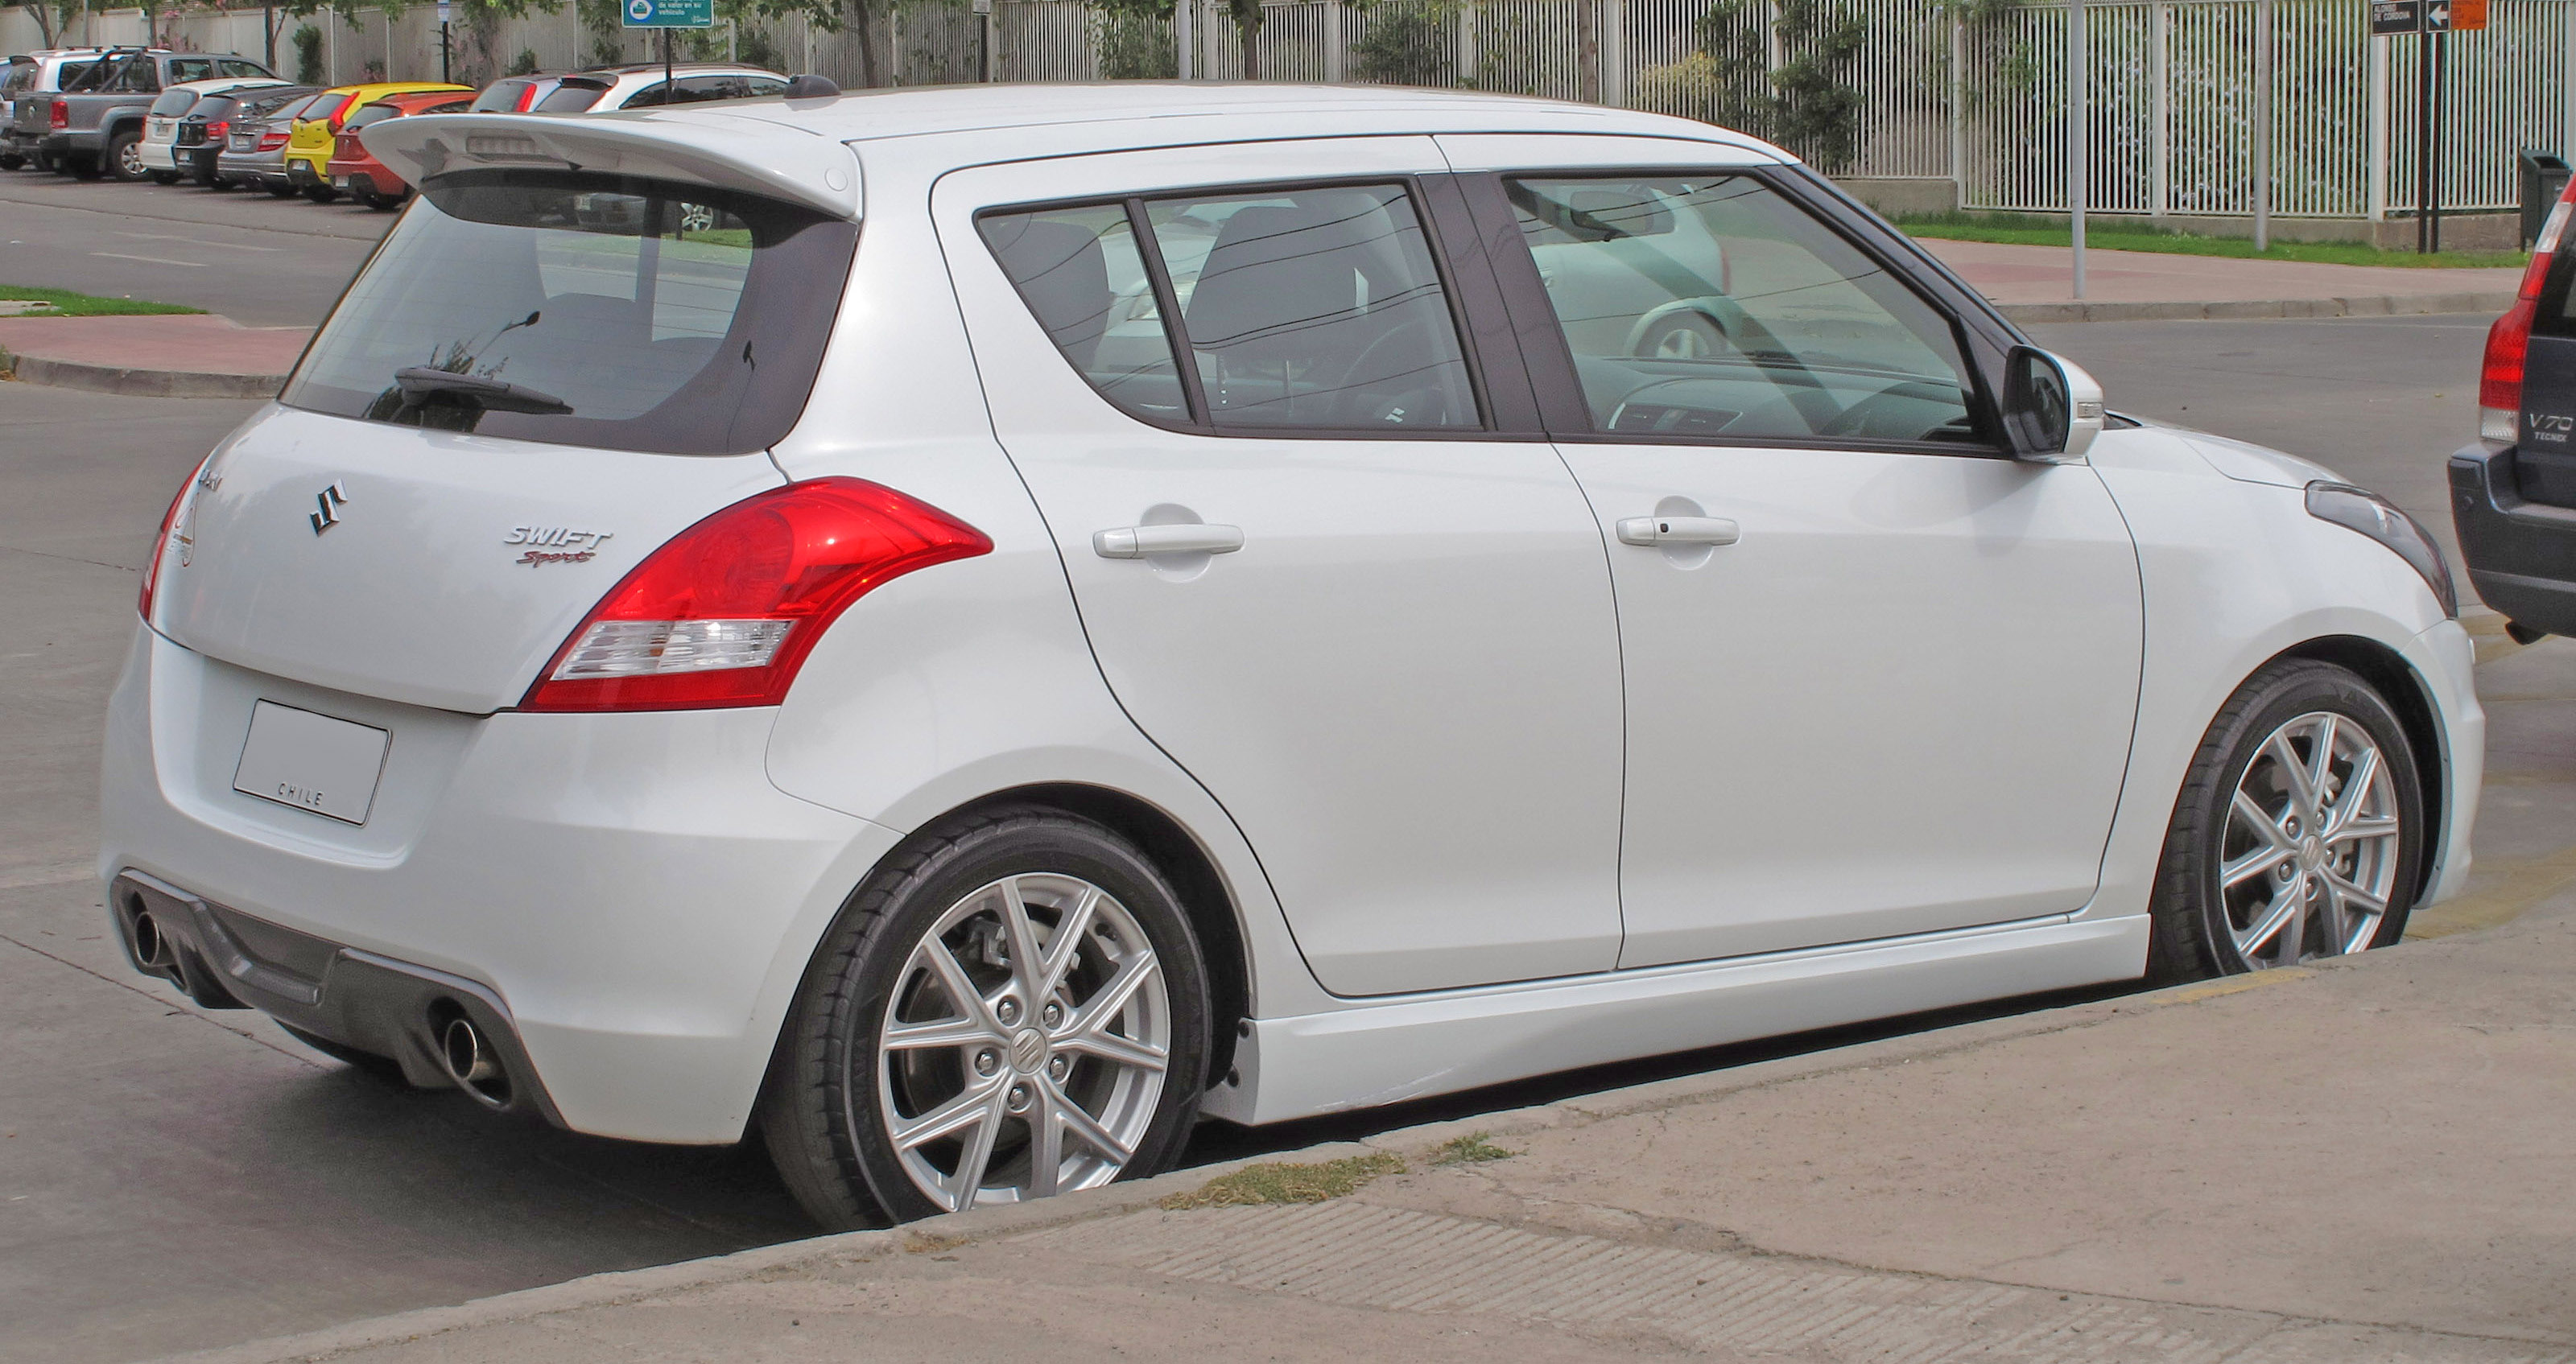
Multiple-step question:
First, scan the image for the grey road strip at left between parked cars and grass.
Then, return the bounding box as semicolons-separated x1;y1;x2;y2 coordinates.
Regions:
0;170;394;327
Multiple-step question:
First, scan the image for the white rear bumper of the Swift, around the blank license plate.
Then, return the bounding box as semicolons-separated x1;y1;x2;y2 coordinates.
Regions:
101;628;897;1143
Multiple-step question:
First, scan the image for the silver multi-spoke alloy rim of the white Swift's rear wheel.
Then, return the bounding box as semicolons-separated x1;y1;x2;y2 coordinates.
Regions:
876;872;1172;1209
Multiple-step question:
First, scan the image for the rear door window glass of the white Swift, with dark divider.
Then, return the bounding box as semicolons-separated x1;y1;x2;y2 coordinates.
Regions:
981;185;1479;432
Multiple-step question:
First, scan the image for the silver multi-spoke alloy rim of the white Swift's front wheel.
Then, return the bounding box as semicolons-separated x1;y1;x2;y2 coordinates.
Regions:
2218;711;2404;970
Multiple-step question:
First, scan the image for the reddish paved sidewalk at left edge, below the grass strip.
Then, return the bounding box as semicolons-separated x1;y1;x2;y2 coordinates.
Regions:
0;314;312;399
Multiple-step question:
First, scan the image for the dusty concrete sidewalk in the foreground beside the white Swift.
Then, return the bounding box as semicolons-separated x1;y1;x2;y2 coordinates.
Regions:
155;641;2576;1364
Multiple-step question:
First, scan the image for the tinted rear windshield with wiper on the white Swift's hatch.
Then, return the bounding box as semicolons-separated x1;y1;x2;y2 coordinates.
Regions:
281;170;858;455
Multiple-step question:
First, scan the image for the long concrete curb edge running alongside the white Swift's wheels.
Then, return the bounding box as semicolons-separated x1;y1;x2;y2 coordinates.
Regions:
159;962;2342;1364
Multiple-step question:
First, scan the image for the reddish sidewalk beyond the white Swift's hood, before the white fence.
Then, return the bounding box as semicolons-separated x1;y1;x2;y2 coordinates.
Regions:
1919;237;2522;322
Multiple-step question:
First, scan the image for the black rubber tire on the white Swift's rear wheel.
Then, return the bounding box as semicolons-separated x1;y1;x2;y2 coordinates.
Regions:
760;808;1211;1230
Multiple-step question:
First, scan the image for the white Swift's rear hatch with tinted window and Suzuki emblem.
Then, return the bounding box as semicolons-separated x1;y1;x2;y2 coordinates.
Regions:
155;170;858;713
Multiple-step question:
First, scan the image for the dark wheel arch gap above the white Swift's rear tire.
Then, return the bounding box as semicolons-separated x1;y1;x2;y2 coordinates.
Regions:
923;782;1252;1083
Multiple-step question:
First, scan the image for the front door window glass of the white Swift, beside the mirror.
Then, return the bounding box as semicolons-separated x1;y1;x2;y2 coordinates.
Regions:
1507;175;1979;443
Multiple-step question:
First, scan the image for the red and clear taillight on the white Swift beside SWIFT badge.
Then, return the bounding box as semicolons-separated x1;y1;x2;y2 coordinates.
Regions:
520;479;992;711
